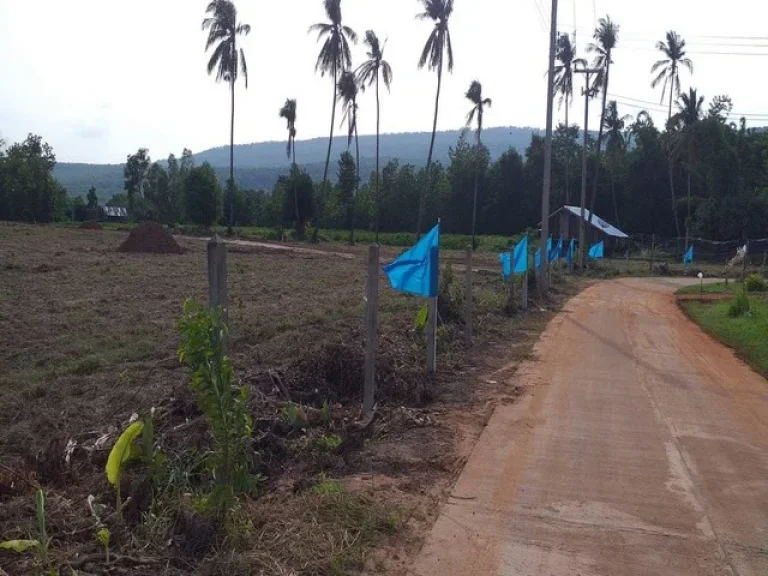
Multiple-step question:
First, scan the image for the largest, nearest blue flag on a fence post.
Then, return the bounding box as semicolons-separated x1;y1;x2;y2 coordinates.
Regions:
384;224;440;297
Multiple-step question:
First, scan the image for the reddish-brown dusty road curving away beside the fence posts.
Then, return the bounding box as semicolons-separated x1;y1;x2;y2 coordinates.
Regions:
413;280;768;576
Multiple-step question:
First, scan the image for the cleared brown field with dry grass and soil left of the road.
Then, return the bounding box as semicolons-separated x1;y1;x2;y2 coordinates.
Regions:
0;224;582;575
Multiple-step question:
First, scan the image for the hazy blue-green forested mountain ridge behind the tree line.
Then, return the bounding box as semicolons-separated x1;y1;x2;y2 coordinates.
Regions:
53;126;538;202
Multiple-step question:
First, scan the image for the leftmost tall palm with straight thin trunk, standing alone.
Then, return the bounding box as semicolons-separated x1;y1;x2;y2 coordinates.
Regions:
202;0;251;233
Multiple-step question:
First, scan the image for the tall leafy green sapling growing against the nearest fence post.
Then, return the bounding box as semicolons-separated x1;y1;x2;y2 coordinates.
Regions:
178;300;255;519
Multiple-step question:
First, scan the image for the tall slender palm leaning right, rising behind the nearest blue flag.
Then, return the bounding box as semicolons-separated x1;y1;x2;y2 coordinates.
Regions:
416;0;453;238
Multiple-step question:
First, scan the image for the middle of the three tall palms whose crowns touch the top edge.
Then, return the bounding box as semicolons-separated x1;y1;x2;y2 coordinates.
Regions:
309;0;357;184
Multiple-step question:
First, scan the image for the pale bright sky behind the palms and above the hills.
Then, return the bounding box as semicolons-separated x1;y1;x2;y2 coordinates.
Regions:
0;0;768;163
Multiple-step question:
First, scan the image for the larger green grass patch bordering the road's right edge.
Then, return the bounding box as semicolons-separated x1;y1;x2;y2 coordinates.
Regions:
681;298;768;376
